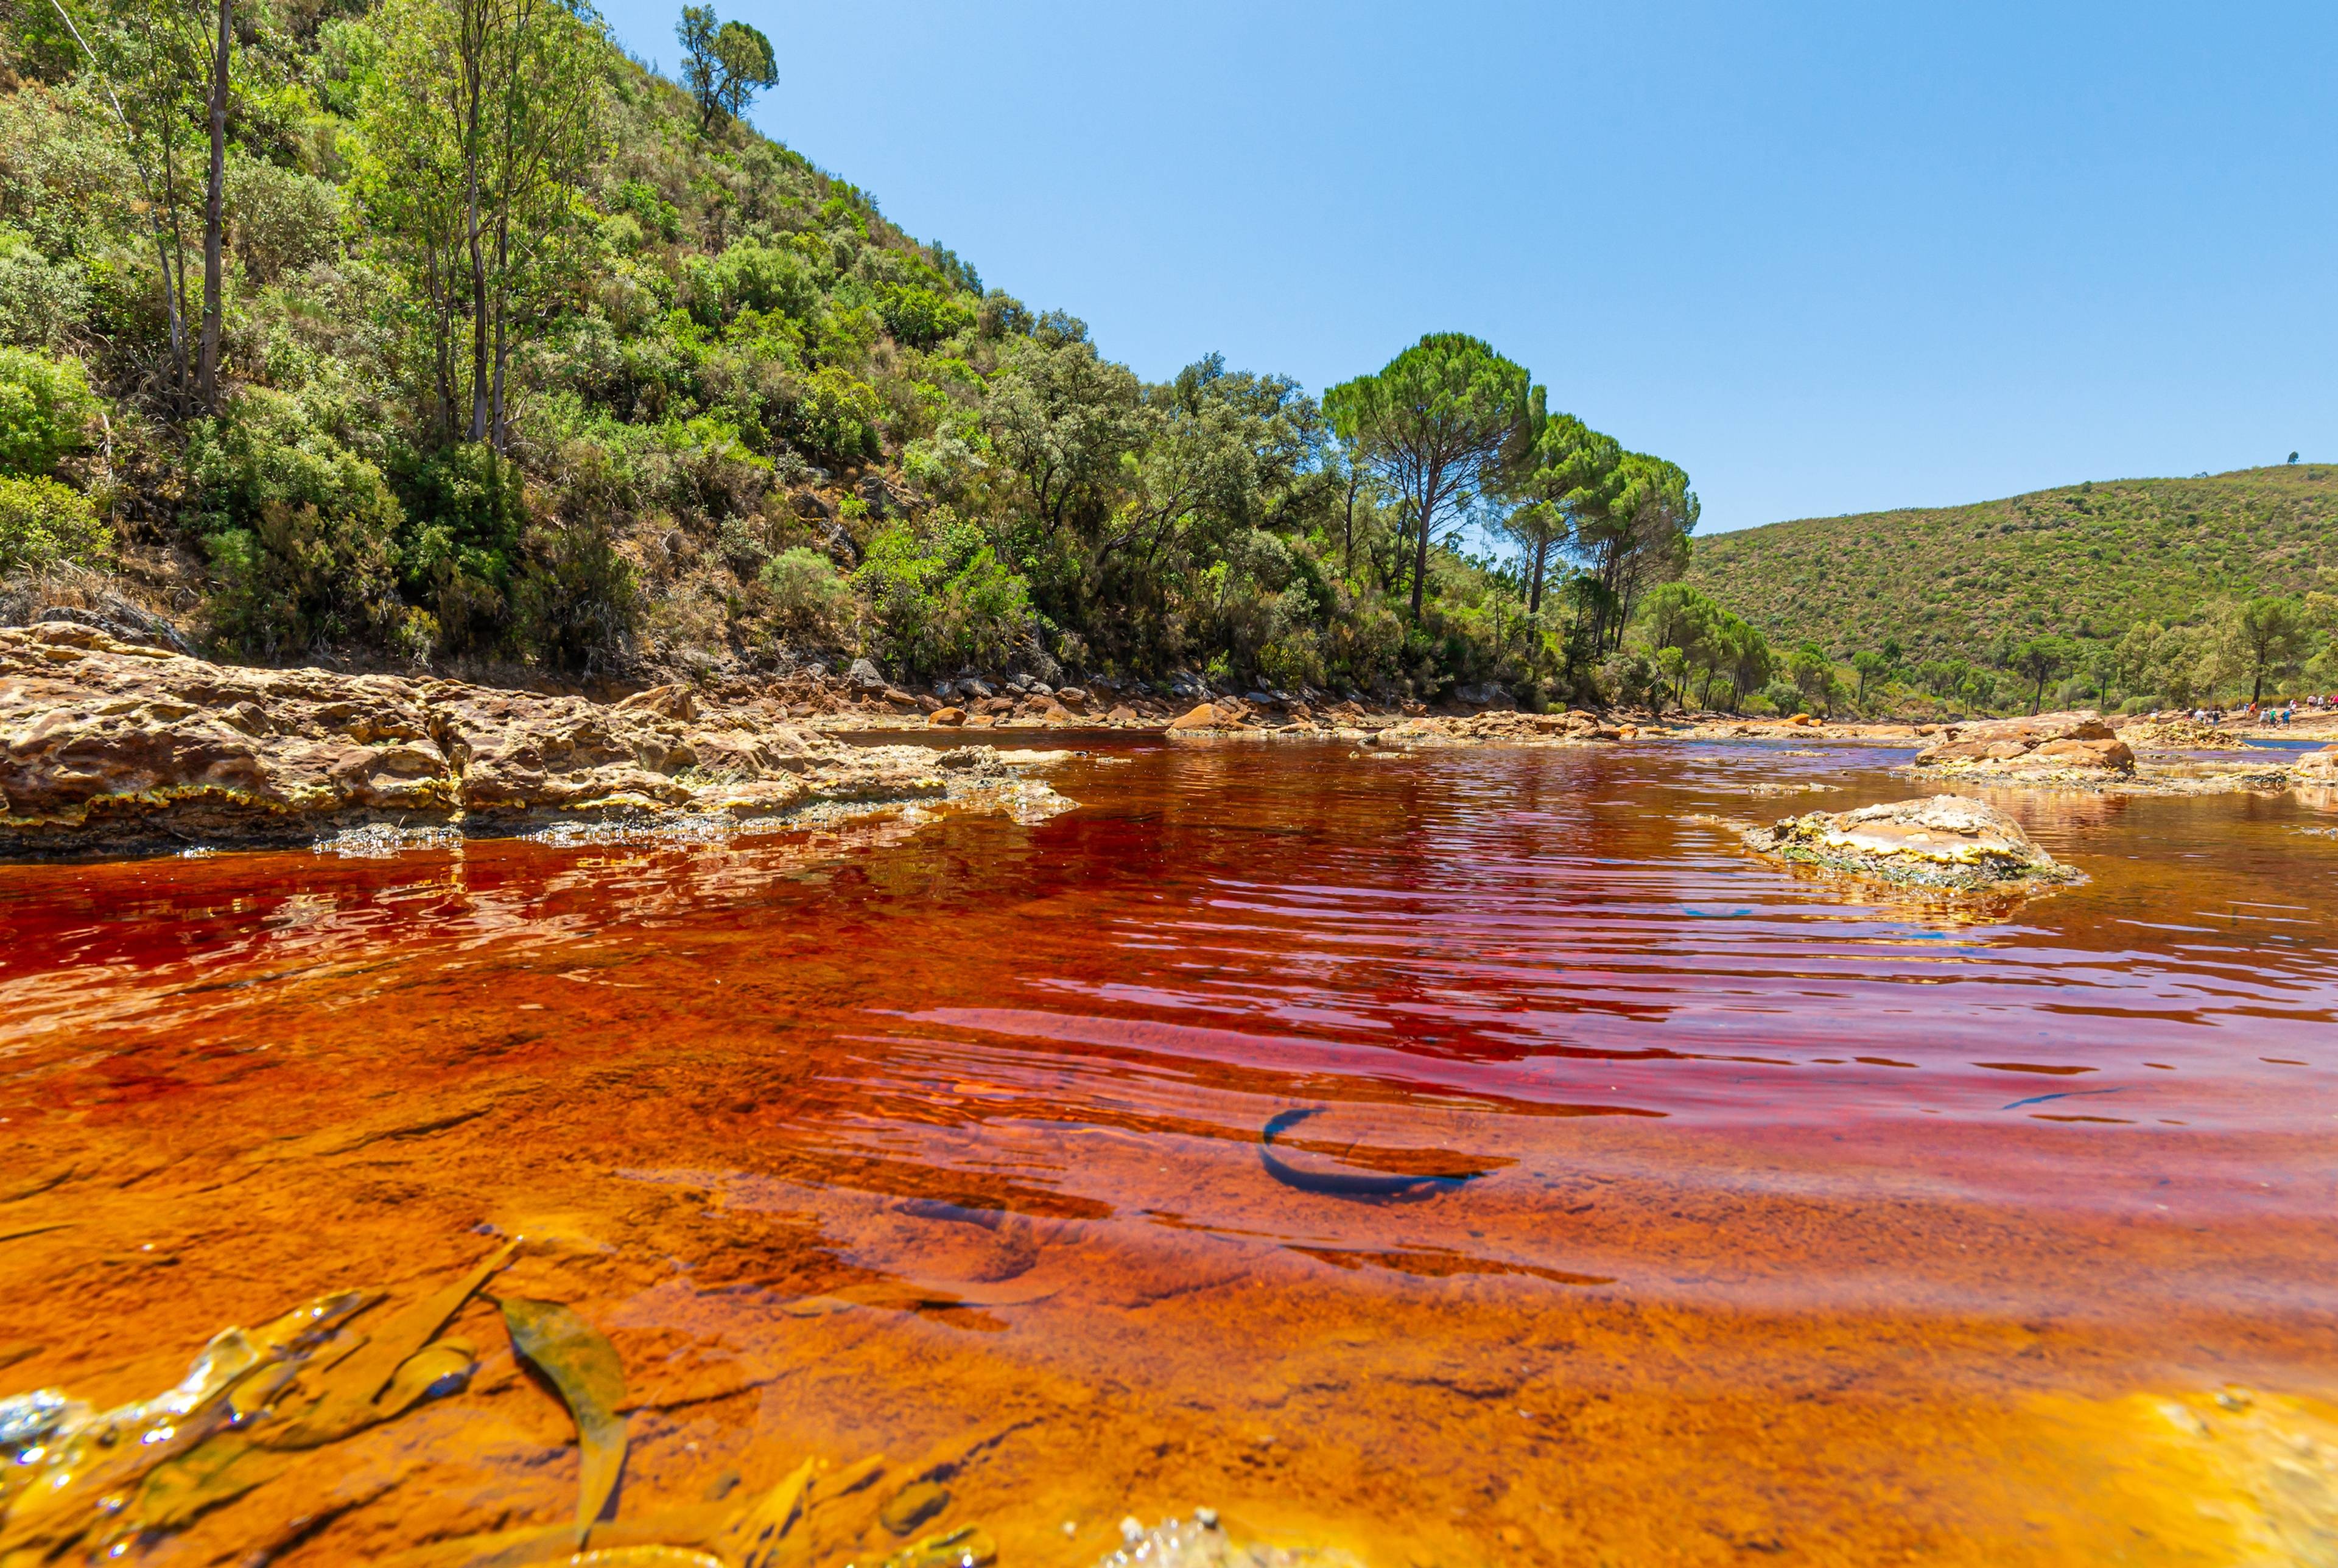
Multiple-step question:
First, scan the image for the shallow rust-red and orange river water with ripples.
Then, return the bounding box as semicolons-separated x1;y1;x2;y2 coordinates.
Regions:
0;738;2338;1566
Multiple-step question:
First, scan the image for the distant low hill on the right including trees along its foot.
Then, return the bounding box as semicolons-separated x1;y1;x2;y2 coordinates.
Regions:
1688;463;2338;705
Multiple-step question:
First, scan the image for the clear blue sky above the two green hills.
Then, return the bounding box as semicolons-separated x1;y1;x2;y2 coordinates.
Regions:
594;0;2338;530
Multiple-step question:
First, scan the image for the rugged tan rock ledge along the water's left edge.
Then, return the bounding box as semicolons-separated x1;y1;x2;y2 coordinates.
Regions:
0;621;1064;855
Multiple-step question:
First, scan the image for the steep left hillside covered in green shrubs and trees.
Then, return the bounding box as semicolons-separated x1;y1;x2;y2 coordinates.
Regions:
0;0;1695;699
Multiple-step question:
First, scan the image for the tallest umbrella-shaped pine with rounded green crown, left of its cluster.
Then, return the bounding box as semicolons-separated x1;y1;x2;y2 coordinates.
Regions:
1323;332;1531;624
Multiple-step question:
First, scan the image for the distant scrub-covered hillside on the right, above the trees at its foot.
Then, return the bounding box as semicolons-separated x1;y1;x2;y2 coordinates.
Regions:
1688;463;2338;659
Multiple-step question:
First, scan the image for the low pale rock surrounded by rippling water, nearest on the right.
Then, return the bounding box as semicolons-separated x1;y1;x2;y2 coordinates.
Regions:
1746;794;2079;891
